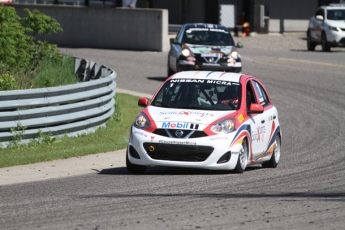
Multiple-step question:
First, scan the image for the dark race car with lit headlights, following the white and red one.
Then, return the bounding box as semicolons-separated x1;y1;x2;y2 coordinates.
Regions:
167;23;243;76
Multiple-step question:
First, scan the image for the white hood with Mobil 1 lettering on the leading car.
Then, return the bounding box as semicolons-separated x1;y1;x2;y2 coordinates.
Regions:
147;106;236;129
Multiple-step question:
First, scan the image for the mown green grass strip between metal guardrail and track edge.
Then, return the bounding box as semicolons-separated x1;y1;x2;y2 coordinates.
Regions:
0;93;142;168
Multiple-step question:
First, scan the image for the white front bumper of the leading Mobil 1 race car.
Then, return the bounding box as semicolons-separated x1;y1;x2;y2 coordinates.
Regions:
128;127;242;170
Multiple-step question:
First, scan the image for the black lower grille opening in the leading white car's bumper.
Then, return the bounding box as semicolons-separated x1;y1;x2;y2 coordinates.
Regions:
143;143;214;162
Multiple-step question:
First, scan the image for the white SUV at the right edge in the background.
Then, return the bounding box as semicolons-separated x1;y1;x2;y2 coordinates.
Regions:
307;4;345;51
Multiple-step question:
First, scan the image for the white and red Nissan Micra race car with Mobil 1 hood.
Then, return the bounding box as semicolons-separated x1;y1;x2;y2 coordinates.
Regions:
126;71;282;174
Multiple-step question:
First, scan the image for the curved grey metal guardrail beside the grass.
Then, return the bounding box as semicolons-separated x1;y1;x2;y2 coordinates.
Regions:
0;58;116;147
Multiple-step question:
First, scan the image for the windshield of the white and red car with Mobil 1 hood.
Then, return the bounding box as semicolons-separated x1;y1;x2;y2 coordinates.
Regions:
151;79;241;110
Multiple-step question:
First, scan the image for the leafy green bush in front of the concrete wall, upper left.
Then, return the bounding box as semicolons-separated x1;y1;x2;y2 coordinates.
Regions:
0;5;62;88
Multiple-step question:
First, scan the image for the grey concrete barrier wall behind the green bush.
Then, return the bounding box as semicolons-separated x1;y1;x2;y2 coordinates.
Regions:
13;4;169;52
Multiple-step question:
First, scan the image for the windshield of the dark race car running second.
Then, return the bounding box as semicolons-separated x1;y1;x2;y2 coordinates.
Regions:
182;28;234;46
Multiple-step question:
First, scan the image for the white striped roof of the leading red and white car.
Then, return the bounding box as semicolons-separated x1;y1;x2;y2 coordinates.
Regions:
171;71;243;82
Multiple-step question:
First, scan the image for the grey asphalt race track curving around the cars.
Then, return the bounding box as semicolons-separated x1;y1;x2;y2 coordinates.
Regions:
0;34;345;230
